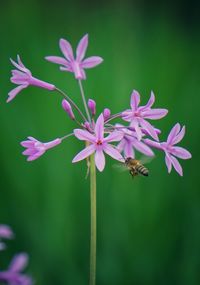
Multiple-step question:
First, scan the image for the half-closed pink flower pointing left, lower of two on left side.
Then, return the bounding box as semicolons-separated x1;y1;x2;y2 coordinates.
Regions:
21;137;62;161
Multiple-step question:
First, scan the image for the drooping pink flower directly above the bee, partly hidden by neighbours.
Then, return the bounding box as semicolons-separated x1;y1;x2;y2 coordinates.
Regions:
116;124;154;158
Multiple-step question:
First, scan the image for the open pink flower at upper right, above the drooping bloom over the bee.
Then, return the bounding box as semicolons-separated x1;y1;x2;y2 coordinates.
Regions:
122;90;168;141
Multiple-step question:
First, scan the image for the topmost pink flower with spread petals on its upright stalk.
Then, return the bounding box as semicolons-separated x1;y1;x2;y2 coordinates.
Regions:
45;34;103;80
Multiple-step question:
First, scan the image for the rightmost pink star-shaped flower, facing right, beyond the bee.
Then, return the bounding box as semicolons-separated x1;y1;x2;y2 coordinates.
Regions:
145;123;192;176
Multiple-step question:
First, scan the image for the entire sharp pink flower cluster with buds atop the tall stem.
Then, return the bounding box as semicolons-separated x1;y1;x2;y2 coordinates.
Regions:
7;35;191;176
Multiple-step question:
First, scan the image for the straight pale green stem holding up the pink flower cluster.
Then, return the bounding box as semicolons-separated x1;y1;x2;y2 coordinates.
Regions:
90;154;96;285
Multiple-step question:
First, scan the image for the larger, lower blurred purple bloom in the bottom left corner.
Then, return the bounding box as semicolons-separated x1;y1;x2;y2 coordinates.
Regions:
0;253;33;285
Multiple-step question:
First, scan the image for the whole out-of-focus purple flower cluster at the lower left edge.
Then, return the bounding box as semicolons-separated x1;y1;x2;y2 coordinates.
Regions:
0;225;33;285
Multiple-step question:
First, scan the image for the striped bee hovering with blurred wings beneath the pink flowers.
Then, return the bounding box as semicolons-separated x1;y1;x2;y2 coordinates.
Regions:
124;157;149;178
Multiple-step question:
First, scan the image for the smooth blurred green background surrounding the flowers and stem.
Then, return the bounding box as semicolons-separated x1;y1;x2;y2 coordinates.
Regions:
0;0;200;285
